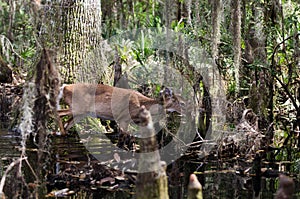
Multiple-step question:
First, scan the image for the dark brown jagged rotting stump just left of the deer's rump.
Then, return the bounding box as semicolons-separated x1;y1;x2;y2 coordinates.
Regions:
33;49;60;198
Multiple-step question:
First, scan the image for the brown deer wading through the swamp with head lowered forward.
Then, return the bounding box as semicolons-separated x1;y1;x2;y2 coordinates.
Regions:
57;83;185;135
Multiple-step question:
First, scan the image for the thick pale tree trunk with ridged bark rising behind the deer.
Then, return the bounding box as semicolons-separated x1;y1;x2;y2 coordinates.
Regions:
37;0;103;83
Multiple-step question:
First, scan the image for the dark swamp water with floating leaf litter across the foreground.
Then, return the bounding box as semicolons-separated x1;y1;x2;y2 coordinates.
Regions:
0;131;300;199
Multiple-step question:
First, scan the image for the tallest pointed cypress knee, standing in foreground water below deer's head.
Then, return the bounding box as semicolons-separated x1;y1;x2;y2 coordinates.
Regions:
136;106;169;199
